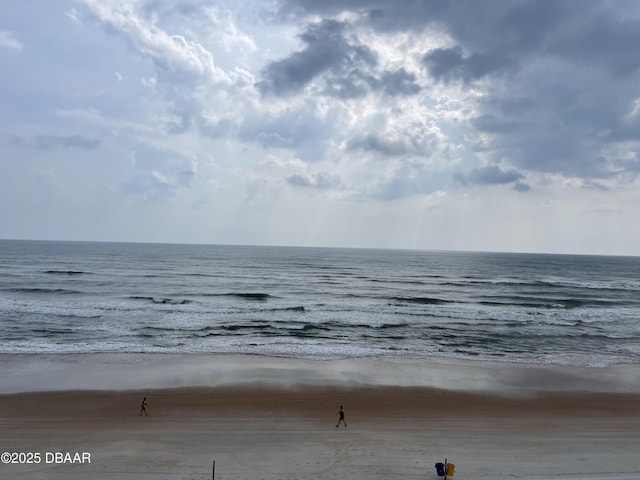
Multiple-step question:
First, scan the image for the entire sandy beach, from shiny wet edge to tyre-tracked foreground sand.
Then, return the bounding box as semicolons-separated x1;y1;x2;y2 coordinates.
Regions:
0;355;640;480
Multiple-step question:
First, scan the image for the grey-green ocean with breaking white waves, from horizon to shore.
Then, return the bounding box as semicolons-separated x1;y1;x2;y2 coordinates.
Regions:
0;240;640;367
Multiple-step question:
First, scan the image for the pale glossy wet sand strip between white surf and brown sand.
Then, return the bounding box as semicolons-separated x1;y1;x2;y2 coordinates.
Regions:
0;353;640;396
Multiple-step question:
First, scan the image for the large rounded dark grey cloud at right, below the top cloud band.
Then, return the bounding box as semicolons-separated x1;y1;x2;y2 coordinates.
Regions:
471;65;640;179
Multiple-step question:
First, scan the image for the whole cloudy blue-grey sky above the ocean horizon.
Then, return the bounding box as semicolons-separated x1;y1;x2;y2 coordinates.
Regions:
0;0;640;255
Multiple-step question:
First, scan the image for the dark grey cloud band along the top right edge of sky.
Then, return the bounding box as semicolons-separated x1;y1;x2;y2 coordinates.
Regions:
281;0;640;81
